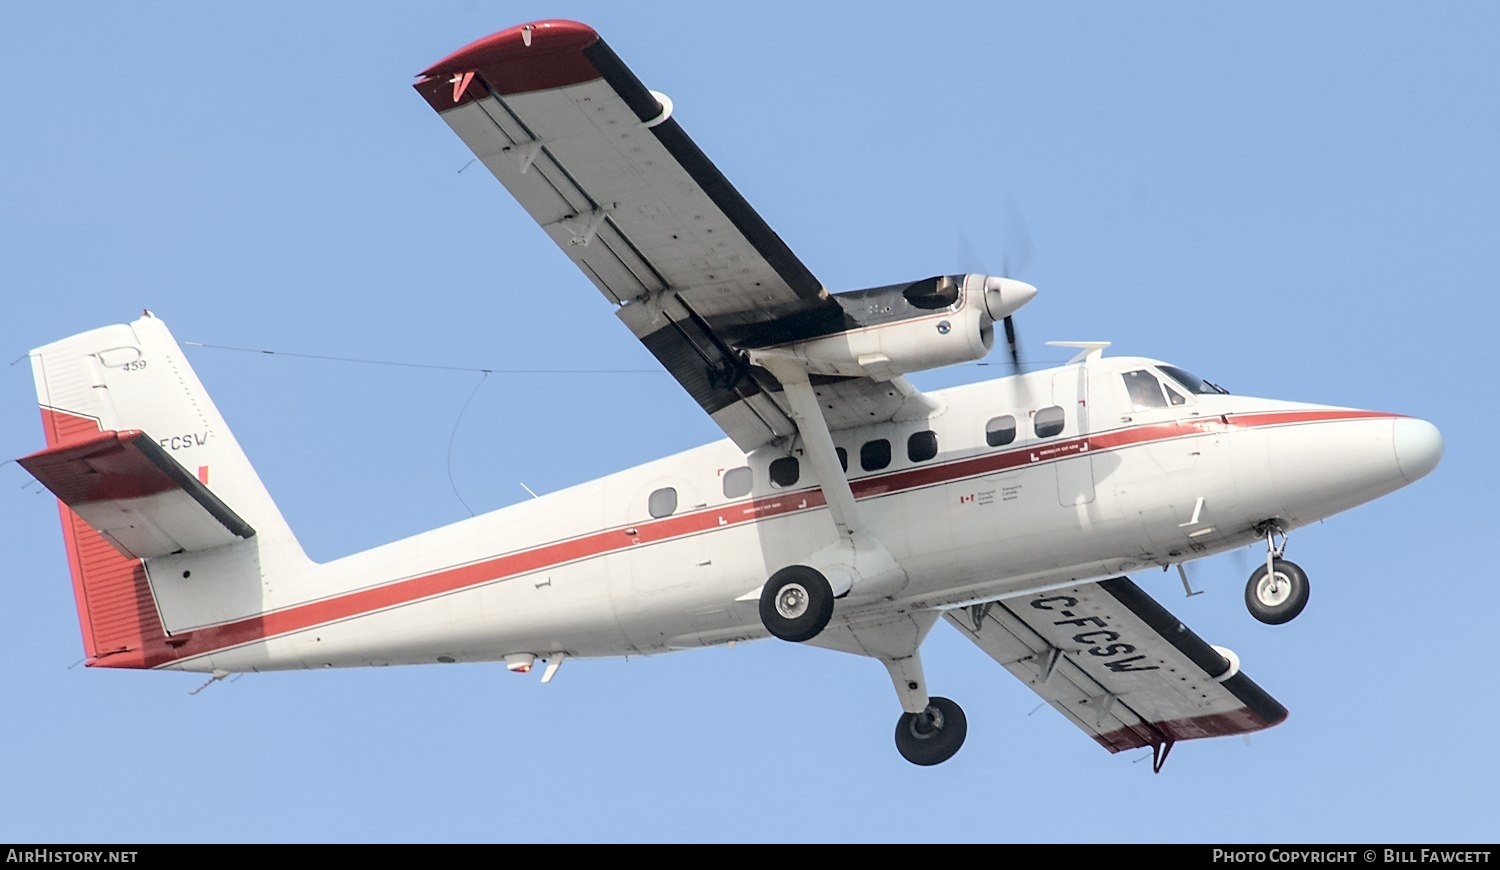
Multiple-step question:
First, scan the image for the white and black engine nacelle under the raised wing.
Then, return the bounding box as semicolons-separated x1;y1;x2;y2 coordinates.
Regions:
758;275;1037;381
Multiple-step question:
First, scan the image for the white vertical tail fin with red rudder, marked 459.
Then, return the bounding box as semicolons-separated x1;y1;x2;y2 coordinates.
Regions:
21;312;308;668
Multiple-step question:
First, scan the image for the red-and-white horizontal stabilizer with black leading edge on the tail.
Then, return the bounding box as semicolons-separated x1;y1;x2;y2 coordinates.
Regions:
18;431;255;560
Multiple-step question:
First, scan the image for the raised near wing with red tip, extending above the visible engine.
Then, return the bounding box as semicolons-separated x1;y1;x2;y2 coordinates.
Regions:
414;21;921;452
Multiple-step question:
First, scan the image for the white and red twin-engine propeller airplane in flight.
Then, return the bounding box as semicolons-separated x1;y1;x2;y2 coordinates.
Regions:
18;20;1443;771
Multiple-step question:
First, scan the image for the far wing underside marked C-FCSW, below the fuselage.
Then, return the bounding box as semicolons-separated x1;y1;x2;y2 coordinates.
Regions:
944;578;1287;762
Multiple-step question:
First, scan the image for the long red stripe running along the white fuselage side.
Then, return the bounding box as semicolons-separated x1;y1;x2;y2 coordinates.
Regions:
138;410;1395;668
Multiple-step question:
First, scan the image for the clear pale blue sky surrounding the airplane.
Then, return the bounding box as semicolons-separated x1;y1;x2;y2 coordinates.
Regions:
0;2;1500;843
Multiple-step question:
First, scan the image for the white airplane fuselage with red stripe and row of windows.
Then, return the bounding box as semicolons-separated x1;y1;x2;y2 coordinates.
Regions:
149;357;1440;672
